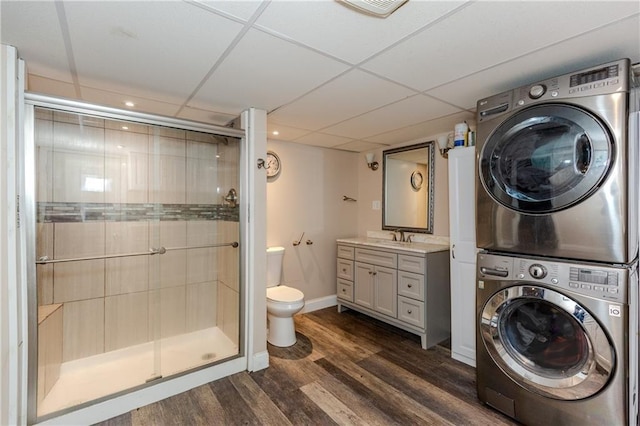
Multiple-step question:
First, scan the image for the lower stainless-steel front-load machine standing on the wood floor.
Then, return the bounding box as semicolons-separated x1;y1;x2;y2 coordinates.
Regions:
476;252;638;426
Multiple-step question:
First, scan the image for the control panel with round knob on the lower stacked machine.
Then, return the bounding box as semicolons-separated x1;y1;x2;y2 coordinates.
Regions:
478;253;630;303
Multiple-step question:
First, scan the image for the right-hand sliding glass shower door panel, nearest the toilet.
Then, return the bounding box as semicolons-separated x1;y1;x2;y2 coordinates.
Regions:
149;126;240;378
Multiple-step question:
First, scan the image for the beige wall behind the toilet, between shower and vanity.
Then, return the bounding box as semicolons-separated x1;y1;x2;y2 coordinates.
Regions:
267;141;364;302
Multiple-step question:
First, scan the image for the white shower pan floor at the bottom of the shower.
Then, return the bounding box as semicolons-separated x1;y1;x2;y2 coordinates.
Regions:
38;327;238;416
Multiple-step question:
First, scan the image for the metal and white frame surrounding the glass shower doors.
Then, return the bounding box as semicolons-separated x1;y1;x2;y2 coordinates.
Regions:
20;92;252;424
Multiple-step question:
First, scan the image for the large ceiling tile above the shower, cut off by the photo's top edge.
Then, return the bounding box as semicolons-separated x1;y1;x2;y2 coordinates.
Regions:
64;1;242;102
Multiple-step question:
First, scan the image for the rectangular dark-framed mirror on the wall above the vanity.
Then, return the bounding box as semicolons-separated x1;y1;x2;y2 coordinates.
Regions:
382;141;435;234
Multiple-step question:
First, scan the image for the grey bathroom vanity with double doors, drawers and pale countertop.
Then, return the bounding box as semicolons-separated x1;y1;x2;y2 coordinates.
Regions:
337;239;450;349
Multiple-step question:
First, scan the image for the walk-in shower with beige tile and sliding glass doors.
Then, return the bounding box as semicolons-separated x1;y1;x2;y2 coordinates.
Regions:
25;96;243;420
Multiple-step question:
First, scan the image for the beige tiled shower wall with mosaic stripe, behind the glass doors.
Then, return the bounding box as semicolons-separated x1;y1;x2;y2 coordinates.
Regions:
36;109;239;361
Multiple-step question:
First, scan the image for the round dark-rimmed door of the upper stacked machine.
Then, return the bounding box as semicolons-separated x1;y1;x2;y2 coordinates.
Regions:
479;103;614;214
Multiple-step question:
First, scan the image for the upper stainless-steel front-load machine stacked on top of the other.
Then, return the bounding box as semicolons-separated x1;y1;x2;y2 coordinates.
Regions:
476;59;638;263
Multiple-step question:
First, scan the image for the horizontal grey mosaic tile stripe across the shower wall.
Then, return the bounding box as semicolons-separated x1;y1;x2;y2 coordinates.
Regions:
36;202;240;223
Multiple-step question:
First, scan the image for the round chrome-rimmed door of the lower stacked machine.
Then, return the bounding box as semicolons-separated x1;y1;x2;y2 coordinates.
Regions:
480;285;616;400
